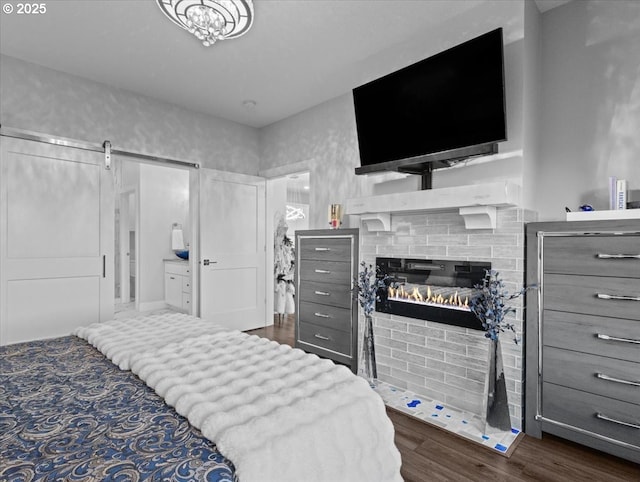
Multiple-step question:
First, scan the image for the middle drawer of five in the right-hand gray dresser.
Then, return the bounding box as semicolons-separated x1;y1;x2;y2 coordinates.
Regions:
542;310;640;361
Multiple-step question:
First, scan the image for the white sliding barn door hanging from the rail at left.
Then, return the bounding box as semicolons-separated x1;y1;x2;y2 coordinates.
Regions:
0;137;114;345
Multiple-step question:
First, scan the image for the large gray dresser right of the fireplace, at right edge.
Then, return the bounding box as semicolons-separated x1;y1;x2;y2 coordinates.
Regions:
525;220;640;462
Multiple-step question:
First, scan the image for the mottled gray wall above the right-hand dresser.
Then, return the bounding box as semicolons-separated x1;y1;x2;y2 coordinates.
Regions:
537;0;640;221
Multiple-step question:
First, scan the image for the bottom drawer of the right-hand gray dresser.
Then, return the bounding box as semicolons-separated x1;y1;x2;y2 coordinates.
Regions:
542;383;640;447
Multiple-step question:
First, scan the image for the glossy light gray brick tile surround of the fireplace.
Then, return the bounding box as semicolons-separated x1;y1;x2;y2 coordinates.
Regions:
359;206;535;429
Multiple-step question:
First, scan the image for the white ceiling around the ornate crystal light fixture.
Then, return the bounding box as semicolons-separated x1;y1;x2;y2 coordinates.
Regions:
0;0;566;127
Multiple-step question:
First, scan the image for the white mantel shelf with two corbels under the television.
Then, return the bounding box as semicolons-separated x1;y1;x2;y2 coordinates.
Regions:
345;181;521;231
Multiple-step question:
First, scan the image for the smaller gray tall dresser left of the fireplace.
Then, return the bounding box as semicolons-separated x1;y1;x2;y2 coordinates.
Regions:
295;229;358;373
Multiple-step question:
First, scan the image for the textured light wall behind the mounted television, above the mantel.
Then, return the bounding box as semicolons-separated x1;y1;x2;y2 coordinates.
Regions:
260;2;524;229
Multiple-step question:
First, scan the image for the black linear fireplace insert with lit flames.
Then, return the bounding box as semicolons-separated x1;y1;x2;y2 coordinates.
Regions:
376;258;491;330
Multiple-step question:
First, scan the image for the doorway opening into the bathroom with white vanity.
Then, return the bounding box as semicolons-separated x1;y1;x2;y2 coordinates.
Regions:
113;158;192;318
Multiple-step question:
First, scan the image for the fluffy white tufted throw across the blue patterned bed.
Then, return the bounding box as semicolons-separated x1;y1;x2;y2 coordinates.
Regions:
76;314;402;482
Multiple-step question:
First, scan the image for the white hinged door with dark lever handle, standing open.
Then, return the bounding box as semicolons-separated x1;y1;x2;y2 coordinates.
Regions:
199;169;267;330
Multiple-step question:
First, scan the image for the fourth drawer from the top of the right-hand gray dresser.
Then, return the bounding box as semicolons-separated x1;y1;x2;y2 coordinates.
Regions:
542;347;640;404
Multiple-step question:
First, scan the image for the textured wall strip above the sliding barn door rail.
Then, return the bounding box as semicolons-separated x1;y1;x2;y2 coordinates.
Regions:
0;55;259;174
